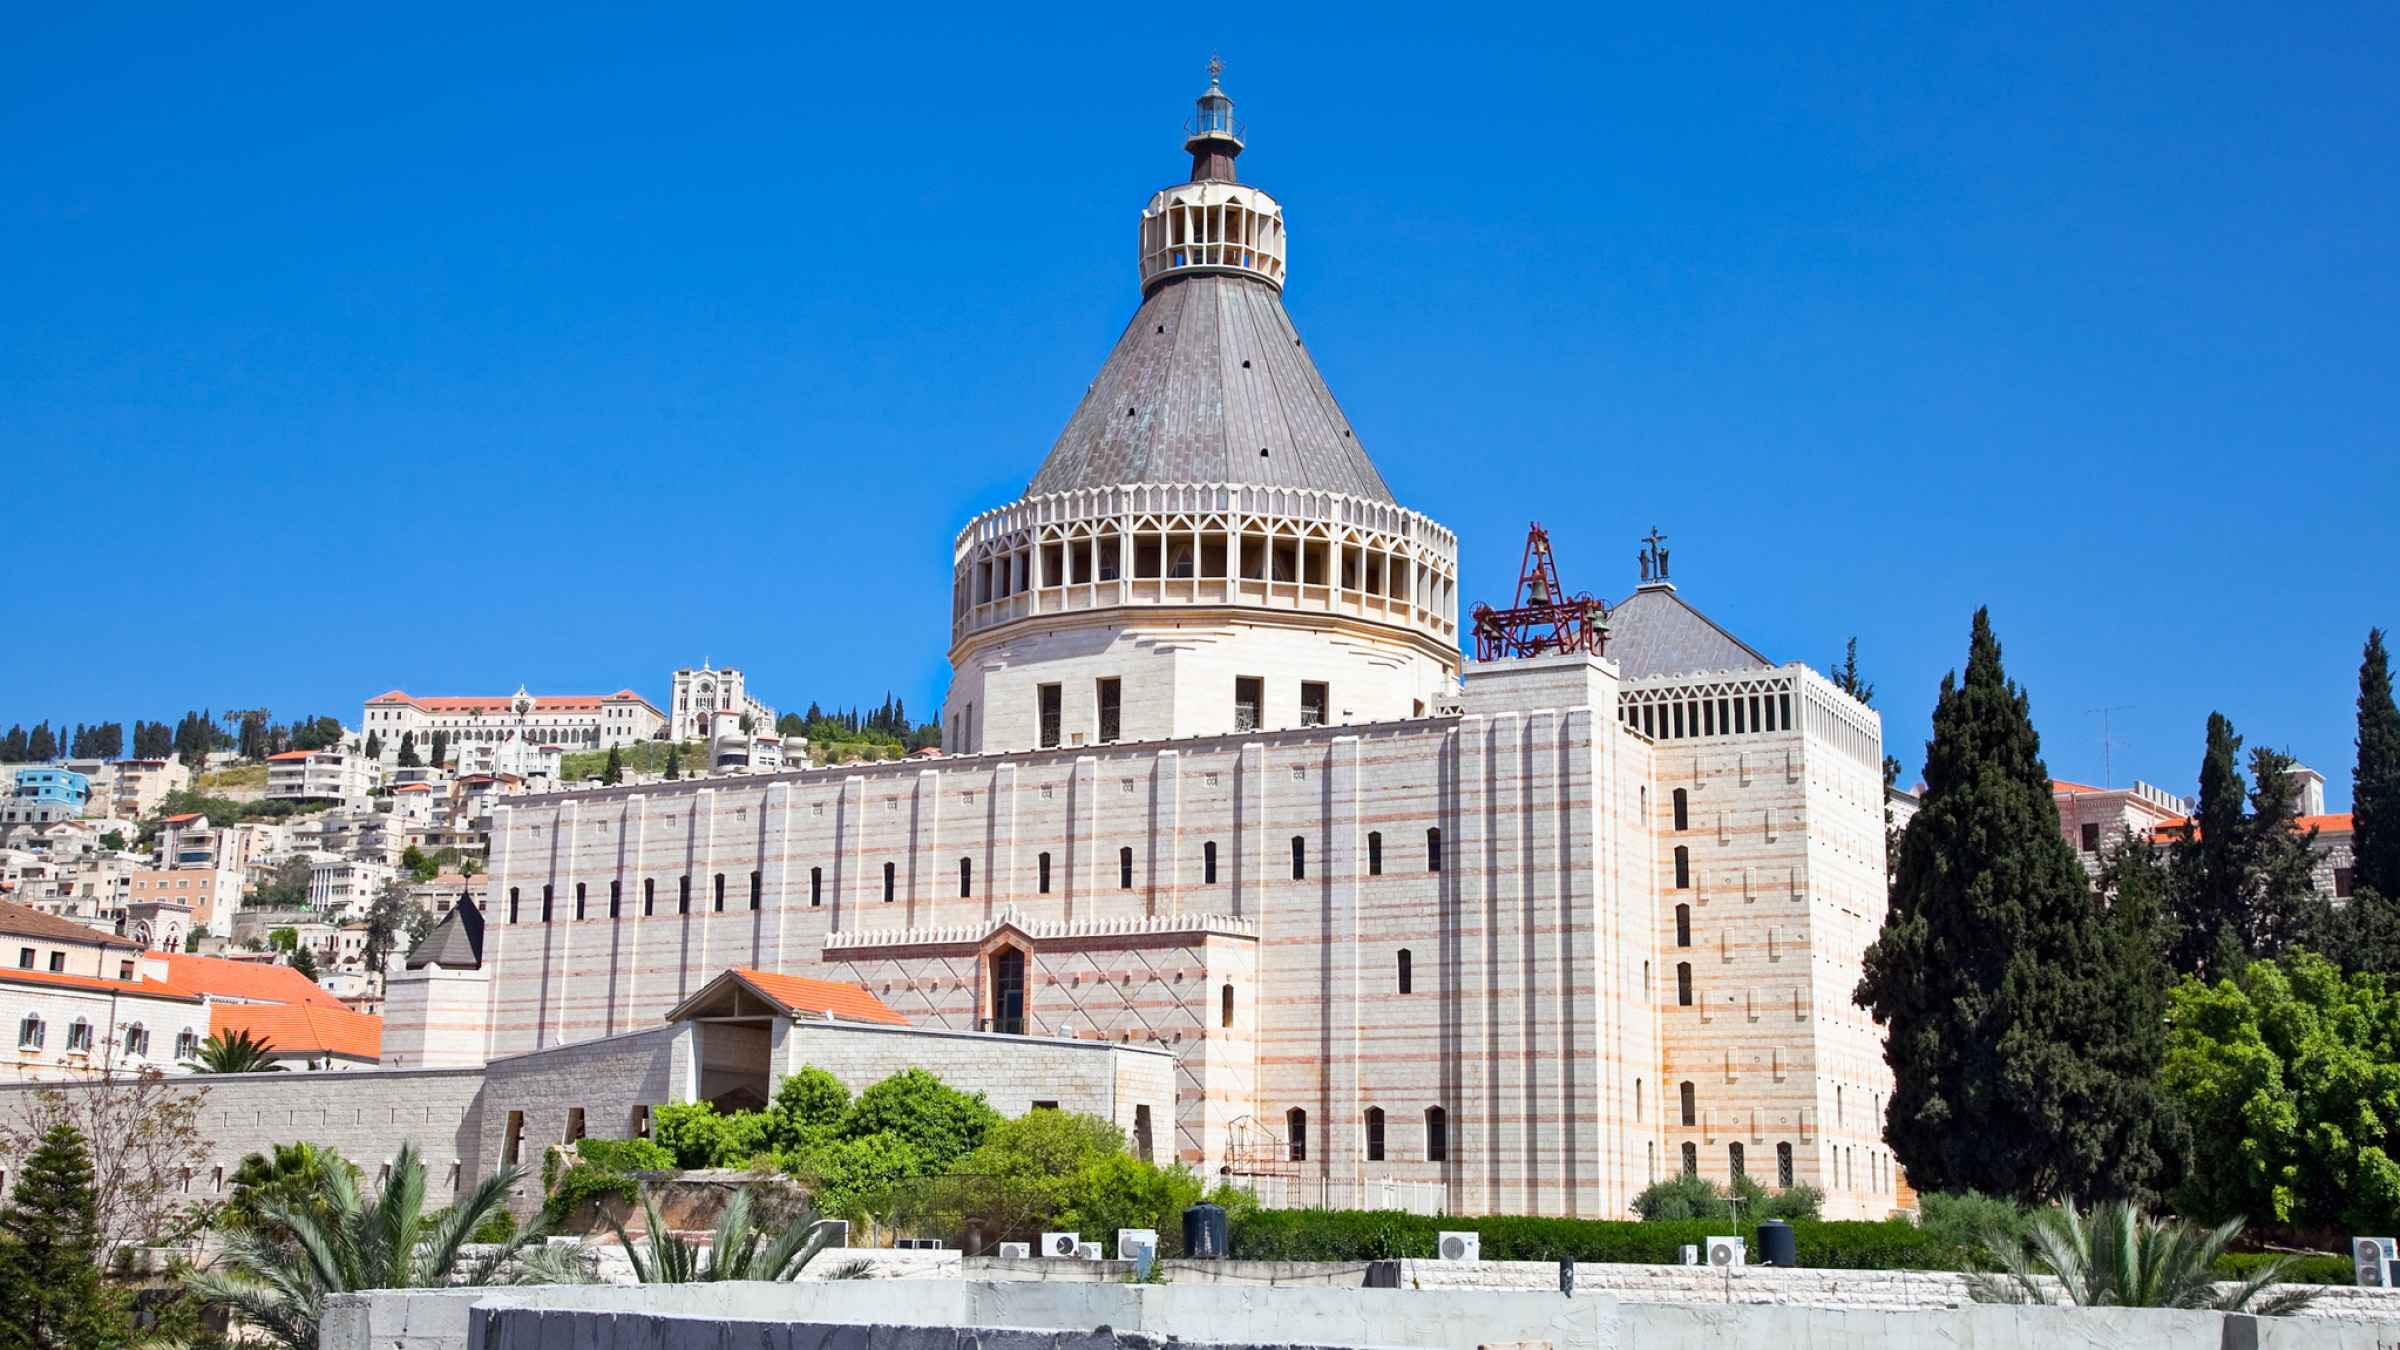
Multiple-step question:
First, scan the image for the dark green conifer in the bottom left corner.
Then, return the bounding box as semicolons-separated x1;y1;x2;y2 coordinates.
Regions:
0;1124;132;1350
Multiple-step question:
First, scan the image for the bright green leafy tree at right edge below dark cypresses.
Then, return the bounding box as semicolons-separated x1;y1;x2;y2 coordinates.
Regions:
2162;951;2400;1232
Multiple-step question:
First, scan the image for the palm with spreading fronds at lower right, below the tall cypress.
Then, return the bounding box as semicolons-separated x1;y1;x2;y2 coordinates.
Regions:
1968;1201;2316;1314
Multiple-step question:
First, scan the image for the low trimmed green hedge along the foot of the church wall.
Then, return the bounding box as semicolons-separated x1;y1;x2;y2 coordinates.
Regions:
1231;1208;1963;1271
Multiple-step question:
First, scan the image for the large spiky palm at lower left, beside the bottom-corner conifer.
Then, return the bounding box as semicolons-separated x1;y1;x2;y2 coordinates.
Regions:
182;1143;590;1350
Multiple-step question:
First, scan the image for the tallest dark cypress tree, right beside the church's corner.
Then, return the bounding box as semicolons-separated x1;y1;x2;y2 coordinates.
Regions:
1855;610;2172;1201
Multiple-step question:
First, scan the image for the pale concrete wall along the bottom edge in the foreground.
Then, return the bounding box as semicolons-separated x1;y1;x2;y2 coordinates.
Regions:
322;1268;2400;1350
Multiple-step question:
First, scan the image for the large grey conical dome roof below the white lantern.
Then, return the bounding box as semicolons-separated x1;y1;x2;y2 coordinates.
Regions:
1025;274;1392;502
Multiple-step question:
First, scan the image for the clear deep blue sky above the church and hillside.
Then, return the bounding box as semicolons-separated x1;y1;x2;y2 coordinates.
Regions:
0;5;2400;805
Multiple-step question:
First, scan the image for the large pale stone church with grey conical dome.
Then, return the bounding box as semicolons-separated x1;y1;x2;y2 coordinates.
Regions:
384;77;1908;1218
